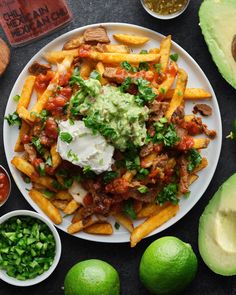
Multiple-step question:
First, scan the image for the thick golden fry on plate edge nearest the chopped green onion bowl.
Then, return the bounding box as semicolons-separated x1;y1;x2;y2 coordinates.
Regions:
29;189;62;224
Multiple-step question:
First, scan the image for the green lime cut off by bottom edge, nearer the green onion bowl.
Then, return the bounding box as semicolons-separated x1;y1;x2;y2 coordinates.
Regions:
64;259;120;295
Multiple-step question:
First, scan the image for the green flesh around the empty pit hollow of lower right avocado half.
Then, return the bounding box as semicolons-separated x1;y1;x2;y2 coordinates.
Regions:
198;173;236;276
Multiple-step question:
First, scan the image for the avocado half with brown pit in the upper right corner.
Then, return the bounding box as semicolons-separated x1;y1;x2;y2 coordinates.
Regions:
199;0;236;88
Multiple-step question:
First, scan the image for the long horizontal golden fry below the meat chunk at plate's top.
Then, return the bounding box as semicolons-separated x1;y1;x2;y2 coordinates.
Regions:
89;51;160;64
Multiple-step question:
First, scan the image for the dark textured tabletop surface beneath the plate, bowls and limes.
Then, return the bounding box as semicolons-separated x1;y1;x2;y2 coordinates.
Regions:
0;0;236;295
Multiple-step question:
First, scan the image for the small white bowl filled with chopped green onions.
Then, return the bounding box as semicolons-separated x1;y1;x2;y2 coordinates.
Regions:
0;210;61;286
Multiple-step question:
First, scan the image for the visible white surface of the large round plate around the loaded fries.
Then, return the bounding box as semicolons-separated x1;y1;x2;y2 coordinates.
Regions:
3;23;222;243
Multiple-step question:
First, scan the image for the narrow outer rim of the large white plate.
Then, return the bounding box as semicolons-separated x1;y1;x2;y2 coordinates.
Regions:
3;22;222;243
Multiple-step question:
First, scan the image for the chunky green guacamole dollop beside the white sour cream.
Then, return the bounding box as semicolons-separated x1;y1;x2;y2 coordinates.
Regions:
73;79;149;151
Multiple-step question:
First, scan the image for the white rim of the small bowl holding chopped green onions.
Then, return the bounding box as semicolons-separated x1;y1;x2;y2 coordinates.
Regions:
0;210;61;287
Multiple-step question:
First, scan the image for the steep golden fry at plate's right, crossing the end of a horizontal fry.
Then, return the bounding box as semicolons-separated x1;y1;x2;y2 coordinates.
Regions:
166;69;188;119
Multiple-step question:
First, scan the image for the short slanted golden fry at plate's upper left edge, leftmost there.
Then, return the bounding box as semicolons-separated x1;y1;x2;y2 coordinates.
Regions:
16;75;36;114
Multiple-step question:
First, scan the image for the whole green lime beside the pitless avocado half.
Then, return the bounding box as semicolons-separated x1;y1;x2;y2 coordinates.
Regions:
139;237;197;295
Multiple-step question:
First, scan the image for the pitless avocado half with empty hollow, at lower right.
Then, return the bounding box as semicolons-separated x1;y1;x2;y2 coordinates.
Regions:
198;174;236;276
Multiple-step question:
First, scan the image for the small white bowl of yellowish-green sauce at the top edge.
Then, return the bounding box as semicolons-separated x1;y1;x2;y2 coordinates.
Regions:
141;0;190;20
